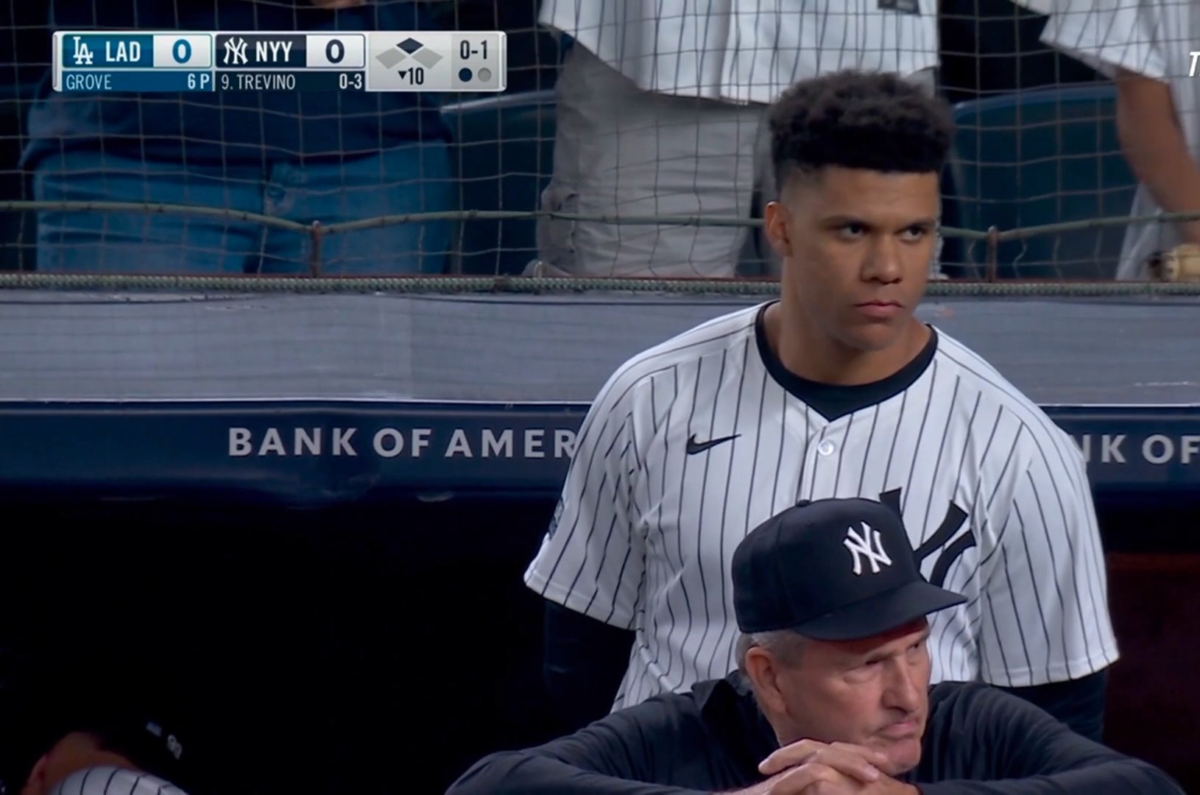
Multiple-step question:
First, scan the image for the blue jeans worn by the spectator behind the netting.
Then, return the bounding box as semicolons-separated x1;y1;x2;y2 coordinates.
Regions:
34;142;454;275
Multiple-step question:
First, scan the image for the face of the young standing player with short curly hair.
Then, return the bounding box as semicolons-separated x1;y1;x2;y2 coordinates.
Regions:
766;167;940;352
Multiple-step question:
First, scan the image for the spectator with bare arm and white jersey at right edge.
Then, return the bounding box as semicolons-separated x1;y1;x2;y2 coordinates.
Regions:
1025;0;1200;280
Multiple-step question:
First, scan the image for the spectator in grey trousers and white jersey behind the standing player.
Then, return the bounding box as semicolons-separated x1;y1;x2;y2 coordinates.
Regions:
539;0;938;277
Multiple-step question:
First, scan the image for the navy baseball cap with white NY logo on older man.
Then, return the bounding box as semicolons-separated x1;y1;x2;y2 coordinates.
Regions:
733;498;966;640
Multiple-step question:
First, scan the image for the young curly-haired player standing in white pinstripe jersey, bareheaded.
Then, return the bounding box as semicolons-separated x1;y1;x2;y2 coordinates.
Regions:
524;66;1117;737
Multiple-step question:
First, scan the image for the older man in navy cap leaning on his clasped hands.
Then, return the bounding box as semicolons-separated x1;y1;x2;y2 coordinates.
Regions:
448;498;1183;795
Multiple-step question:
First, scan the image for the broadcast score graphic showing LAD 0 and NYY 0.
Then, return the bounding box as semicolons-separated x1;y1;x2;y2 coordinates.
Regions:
54;30;508;94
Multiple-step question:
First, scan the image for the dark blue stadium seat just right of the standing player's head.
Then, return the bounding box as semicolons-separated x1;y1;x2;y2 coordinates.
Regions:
943;84;1138;279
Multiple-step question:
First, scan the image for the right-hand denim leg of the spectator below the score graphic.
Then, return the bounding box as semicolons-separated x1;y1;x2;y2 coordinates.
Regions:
263;141;454;276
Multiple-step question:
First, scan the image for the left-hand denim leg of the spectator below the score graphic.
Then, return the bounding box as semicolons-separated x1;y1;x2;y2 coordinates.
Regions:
34;150;264;274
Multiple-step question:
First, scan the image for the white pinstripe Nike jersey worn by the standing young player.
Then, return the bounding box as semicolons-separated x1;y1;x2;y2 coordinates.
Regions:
526;306;1117;709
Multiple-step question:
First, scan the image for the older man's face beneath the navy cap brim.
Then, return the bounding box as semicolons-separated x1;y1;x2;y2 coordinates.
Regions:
780;620;930;776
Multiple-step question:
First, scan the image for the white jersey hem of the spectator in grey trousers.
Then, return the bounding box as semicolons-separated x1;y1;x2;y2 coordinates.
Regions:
538;0;938;103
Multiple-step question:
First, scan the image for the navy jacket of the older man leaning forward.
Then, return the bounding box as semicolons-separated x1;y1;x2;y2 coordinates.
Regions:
448;674;1183;795
